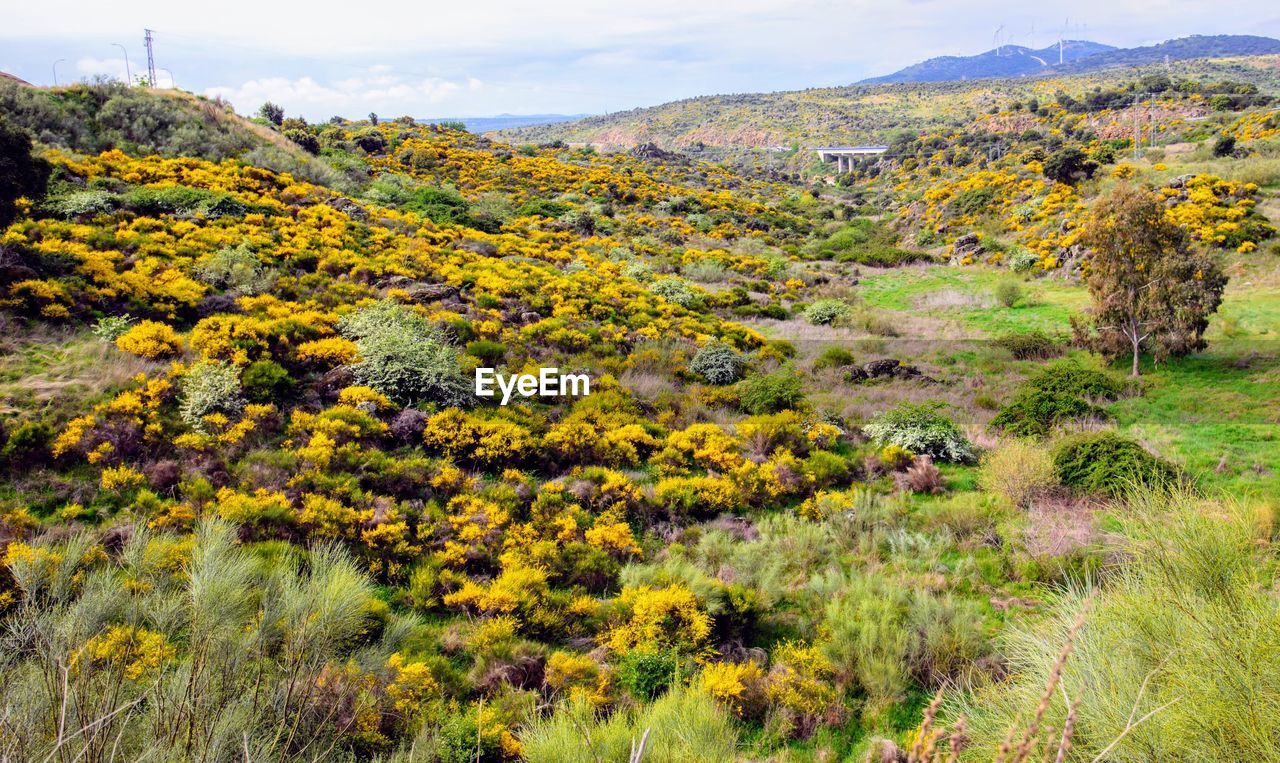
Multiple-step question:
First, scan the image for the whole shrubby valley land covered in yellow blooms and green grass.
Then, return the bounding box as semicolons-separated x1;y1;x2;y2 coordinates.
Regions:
0;72;1280;763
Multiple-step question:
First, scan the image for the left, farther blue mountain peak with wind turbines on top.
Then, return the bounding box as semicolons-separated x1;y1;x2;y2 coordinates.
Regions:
859;40;1116;84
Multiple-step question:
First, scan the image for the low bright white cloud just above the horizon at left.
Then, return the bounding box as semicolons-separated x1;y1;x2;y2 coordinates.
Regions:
205;71;484;116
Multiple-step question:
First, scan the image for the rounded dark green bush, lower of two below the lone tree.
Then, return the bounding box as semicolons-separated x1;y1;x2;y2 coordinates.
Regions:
1053;430;1180;498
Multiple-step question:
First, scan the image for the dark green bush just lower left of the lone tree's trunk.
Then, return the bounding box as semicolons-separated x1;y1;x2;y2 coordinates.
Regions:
991;361;1121;437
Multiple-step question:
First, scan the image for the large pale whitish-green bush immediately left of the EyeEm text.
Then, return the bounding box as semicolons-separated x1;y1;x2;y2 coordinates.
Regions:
338;301;472;406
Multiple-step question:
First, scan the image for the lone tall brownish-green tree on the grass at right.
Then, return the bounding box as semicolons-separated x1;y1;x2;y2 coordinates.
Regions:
1071;184;1226;376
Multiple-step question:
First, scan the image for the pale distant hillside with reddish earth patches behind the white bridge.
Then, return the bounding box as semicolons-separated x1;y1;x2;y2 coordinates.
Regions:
497;56;1280;149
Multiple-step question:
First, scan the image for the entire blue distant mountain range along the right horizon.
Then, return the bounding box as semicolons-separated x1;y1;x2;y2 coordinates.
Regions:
859;35;1280;84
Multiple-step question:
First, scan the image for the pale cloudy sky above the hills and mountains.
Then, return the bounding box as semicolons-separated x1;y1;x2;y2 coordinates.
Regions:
0;0;1280;120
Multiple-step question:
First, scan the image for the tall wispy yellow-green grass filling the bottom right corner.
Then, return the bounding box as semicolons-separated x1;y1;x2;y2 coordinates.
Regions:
948;490;1280;762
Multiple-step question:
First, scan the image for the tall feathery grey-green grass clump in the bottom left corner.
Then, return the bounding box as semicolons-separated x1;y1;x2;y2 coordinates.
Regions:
0;524;384;763
